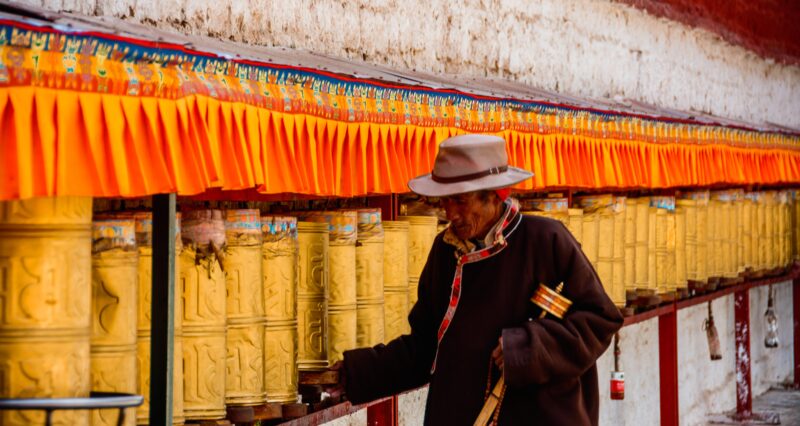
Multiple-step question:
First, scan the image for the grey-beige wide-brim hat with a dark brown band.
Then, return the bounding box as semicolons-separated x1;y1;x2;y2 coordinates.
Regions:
408;134;533;197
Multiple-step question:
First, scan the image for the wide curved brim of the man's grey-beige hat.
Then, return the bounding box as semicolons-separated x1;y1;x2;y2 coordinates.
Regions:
408;166;533;197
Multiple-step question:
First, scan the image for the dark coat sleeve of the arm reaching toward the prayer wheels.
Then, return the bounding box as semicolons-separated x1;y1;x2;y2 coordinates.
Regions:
344;240;442;404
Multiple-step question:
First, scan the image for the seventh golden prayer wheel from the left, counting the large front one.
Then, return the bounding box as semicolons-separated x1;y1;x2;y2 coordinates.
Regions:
297;222;329;371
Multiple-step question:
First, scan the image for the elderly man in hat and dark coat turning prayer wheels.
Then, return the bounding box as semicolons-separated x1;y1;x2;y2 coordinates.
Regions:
340;135;622;425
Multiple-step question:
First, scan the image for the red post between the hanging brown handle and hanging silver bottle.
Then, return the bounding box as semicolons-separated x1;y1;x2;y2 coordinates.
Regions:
734;288;753;418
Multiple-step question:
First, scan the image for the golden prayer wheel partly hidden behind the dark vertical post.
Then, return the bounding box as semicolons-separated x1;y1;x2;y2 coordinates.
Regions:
133;212;184;425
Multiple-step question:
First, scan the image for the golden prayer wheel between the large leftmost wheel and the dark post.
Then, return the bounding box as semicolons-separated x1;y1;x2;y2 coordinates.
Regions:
91;218;139;425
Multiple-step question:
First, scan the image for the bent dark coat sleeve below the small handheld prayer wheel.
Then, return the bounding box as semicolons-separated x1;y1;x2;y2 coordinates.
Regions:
502;224;623;387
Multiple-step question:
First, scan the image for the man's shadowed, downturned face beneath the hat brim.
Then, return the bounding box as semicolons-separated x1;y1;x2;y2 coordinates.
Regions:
441;192;502;240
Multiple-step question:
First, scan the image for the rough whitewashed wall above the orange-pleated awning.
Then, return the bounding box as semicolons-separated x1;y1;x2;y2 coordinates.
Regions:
15;0;800;128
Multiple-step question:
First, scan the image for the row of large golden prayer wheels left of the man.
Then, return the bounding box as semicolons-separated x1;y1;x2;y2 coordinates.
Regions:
0;197;437;425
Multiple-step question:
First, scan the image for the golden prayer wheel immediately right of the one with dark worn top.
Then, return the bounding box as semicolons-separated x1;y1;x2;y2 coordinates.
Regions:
225;209;266;405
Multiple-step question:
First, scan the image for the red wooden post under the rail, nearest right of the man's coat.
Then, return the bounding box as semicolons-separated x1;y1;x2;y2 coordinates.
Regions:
658;309;678;426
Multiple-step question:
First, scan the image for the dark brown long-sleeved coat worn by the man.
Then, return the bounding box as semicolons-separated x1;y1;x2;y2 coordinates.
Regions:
344;216;622;425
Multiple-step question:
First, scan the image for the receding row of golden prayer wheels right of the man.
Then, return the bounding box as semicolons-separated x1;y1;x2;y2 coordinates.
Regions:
522;190;800;306
